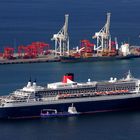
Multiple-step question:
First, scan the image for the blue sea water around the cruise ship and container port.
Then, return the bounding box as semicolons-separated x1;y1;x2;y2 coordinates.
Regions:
0;0;140;140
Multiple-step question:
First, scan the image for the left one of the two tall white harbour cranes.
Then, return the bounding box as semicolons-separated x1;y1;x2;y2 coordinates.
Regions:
51;15;69;56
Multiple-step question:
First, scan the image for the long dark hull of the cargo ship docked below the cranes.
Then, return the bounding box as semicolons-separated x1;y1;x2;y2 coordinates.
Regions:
60;55;140;62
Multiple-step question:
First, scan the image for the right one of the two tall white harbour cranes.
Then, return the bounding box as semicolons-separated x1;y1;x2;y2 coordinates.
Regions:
92;13;111;51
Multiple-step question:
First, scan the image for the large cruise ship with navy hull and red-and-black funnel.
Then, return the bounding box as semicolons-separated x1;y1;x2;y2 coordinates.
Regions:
0;71;140;119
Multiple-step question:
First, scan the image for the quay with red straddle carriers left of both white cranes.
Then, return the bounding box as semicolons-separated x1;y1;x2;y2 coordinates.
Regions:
0;42;60;64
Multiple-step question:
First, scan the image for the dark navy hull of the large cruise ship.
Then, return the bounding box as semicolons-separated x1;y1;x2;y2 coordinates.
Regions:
0;97;140;119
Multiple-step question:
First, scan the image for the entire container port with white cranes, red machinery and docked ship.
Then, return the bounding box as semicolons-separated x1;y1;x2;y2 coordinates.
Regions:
0;13;140;64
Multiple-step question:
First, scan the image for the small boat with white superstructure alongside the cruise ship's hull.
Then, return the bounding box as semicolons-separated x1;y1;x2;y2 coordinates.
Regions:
40;103;80;118
